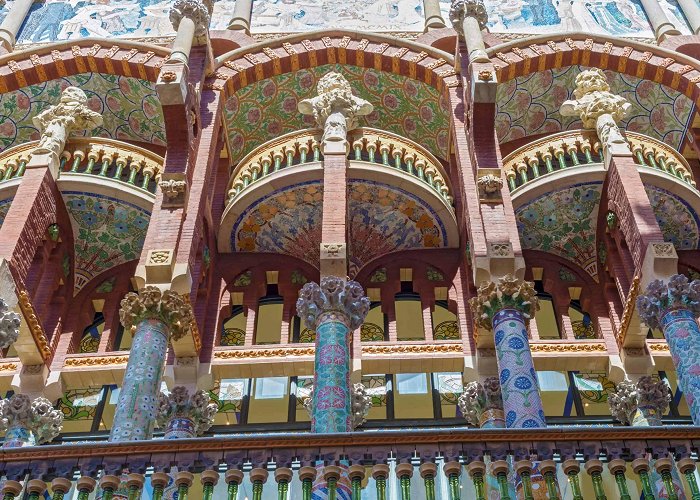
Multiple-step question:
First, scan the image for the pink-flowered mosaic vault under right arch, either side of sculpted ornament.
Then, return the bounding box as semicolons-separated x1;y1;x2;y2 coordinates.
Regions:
496;66;694;149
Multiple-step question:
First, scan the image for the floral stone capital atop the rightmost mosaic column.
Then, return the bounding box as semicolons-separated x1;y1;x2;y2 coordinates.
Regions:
637;274;700;328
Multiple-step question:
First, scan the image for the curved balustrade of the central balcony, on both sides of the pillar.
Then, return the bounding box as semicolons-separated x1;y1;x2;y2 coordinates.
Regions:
228;128;452;203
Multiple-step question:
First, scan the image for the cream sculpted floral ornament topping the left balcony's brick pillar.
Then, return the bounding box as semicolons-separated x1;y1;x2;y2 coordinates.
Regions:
32;87;102;161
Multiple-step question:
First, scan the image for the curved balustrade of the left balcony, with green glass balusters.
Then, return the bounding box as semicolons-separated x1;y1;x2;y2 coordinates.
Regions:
0;137;163;193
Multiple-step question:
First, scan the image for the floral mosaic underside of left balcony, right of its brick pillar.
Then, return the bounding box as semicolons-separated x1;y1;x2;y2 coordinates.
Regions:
63;191;151;294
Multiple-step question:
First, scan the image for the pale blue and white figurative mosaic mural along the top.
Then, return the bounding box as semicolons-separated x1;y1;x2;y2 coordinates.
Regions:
0;0;690;43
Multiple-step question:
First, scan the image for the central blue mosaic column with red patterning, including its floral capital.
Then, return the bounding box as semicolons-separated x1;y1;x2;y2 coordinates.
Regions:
297;276;369;433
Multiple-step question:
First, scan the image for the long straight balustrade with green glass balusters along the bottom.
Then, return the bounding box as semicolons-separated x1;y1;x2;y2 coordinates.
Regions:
0;426;700;500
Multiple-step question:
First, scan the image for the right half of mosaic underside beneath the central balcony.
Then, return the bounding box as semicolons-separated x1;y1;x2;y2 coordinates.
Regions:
348;179;448;276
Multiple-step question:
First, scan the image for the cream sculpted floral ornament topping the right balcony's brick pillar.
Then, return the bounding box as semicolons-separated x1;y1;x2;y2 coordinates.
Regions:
559;68;632;154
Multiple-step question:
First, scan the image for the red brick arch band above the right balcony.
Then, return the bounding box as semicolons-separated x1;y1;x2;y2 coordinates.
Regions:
488;33;700;102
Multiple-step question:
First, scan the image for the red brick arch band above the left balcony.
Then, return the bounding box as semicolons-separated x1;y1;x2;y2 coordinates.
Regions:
0;38;170;93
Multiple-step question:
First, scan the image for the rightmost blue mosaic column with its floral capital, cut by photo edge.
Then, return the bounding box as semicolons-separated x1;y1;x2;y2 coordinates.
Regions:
637;274;700;425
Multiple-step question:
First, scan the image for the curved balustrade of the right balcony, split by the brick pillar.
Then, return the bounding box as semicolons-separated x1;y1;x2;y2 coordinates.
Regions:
503;130;695;191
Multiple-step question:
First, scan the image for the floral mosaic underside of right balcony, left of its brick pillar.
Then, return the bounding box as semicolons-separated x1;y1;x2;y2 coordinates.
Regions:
515;182;602;281
